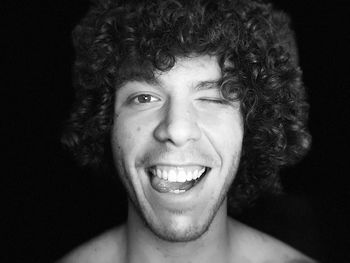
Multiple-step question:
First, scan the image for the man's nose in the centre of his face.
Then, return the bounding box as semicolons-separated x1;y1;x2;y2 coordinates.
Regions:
154;102;201;147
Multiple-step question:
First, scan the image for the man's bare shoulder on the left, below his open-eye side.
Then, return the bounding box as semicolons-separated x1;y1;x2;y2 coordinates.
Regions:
57;225;126;263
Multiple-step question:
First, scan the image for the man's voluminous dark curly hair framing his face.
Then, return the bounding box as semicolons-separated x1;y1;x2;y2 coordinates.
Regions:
62;0;311;212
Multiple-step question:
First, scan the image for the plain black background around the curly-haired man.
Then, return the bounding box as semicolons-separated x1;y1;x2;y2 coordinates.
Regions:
0;0;350;263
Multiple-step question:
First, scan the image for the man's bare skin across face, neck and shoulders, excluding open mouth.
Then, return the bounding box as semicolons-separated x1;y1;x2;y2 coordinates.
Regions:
58;56;313;263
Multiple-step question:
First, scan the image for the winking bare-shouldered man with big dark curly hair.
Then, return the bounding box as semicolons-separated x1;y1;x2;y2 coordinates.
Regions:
58;0;314;263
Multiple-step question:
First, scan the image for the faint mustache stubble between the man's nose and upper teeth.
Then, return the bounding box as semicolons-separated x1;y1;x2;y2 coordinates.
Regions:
137;146;221;167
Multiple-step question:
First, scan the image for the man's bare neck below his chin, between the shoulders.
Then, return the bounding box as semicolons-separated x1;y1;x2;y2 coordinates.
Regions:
127;200;230;263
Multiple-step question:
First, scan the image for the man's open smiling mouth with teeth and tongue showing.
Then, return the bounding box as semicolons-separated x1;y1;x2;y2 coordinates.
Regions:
147;165;210;194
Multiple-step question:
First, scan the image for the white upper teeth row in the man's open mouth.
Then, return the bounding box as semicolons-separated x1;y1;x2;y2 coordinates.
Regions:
150;167;205;183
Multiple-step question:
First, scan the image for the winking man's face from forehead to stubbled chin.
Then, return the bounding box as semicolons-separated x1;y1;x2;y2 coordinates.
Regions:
112;56;243;241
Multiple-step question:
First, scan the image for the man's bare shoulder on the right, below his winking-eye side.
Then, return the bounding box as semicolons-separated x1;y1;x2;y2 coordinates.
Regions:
230;220;316;263
